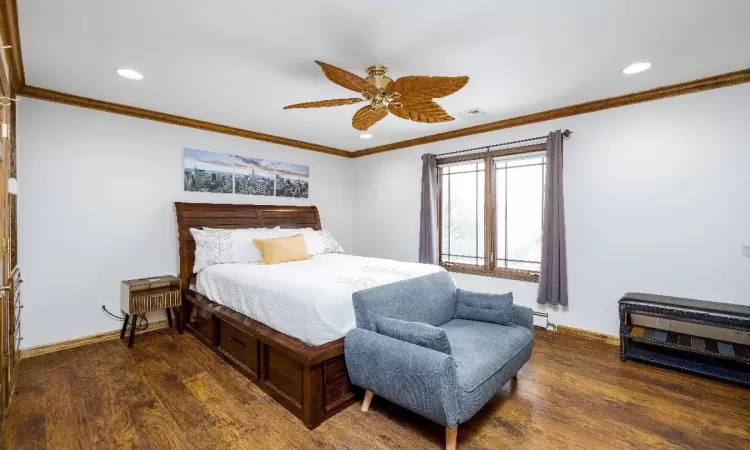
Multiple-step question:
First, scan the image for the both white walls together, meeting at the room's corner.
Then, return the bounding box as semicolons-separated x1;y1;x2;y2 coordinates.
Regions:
18;84;750;347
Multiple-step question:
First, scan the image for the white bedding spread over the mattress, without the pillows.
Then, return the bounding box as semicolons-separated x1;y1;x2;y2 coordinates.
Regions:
196;253;445;345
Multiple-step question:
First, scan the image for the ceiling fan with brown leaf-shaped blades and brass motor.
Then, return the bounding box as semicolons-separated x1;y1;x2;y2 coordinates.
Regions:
284;61;469;131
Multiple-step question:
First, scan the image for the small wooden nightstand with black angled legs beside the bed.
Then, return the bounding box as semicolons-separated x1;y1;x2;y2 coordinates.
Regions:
120;275;182;348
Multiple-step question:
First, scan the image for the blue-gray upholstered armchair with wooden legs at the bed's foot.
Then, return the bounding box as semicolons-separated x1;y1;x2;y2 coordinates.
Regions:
344;272;533;449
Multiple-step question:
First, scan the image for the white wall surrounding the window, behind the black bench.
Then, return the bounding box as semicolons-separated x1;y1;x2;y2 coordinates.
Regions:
353;84;750;334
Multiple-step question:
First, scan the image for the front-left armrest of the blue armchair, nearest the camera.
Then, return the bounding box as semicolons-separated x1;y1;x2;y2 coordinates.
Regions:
344;328;459;427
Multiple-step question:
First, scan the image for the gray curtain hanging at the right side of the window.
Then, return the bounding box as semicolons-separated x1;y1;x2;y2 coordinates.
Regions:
537;130;568;306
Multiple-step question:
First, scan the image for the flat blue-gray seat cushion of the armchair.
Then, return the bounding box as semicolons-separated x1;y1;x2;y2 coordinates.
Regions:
440;319;533;391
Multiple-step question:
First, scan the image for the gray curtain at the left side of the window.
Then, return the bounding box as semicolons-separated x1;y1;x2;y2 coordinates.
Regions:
419;153;438;264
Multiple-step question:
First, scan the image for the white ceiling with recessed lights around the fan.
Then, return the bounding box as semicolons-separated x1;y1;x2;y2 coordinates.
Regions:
19;0;750;150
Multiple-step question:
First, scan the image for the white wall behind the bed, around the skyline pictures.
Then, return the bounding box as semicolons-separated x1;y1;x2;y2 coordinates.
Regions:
17;98;353;347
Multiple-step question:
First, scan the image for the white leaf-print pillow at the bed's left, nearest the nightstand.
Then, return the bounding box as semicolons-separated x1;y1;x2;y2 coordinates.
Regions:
190;228;278;273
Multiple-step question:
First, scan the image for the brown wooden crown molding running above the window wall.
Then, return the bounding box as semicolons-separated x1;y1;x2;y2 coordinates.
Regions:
351;69;750;158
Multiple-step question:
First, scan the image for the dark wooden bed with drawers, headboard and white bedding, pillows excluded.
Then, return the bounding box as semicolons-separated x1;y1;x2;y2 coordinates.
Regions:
175;202;443;429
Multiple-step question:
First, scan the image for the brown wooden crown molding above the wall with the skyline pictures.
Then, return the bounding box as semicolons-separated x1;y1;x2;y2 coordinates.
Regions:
20;86;352;158
